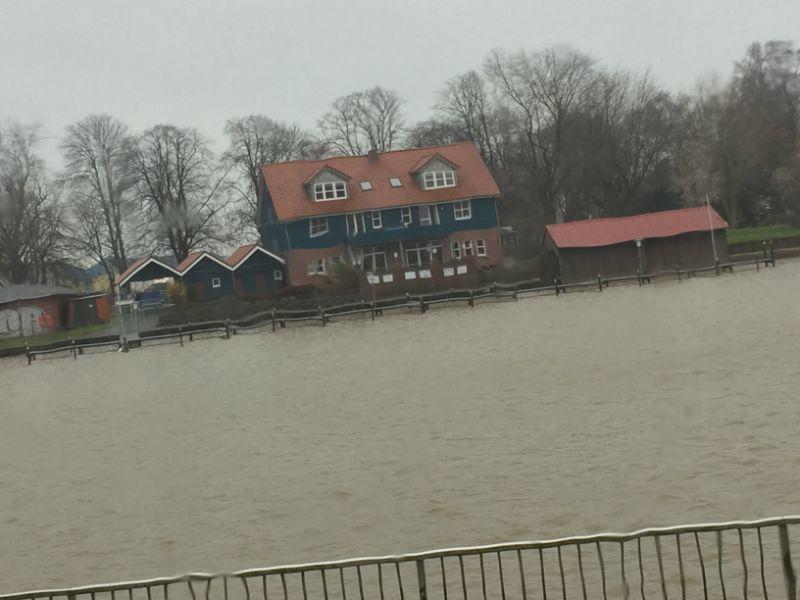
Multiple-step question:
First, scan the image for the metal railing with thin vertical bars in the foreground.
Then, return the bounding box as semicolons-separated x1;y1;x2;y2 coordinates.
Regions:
6;516;800;600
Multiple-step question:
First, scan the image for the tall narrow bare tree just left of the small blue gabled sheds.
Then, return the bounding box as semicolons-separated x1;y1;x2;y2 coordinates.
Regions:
61;115;136;289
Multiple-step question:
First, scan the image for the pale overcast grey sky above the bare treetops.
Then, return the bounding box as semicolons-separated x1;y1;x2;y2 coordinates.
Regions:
0;0;800;166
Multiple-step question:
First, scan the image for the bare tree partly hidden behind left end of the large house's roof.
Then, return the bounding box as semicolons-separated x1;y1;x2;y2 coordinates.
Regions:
223;115;319;229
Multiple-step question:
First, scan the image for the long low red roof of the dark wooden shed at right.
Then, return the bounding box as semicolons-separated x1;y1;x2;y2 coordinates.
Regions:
547;206;728;248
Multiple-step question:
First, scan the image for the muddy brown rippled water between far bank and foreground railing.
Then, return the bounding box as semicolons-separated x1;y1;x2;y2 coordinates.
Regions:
0;262;800;592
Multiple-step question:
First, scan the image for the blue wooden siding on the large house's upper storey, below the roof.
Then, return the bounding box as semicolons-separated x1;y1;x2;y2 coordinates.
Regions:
262;196;497;250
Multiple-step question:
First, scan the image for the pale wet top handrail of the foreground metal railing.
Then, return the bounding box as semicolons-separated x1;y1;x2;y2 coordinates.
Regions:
0;515;800;600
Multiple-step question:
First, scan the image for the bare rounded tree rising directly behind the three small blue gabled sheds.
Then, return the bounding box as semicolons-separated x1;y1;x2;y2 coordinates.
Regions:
133;125;227;261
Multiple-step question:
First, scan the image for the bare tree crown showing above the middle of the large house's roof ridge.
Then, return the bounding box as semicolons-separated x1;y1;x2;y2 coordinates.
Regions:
319;87;405;156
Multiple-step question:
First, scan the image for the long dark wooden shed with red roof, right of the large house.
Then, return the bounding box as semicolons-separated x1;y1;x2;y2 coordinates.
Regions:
542;206;728;283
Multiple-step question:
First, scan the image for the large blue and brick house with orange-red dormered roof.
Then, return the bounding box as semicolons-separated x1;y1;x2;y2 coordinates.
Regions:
259;142;502;285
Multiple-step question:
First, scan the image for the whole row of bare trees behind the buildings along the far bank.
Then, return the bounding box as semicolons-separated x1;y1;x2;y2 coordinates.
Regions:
0;41;800;282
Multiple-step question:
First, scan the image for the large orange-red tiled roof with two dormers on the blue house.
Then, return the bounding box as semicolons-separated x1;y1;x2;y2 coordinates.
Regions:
261;142;500;221
